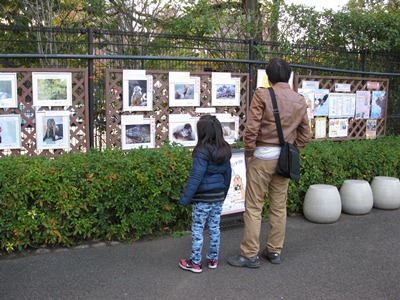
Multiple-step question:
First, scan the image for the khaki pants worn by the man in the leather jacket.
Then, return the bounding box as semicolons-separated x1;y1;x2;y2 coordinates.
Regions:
240;157;289;258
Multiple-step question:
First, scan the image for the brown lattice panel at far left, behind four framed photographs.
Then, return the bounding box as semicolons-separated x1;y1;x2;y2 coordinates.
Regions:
0;69;89;157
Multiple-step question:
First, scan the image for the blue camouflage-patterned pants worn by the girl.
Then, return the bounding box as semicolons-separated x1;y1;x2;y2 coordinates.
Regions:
190;201;223;264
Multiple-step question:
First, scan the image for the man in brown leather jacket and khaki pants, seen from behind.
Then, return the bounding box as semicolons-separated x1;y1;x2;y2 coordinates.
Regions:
228;58;311;268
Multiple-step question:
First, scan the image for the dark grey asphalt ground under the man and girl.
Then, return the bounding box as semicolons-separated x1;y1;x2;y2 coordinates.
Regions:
0;209;400;300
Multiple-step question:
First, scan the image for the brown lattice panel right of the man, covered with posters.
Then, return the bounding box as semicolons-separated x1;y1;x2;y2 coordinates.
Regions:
294;75;389;140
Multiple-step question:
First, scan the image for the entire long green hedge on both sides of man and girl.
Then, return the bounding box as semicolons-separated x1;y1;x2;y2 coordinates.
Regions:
0;136;400;252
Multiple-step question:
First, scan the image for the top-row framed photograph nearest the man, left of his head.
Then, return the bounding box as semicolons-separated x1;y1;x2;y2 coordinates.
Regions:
211;73;240;106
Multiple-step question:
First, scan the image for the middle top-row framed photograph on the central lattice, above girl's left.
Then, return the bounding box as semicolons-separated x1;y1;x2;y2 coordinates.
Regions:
169;72;200;107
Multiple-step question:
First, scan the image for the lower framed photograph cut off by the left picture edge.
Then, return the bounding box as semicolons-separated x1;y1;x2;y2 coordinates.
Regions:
0;115;21;149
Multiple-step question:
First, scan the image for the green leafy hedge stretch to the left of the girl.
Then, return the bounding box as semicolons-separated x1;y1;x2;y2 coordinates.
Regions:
0;144;191;252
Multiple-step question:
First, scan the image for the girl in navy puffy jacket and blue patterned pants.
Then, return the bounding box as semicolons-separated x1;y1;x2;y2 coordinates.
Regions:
179;115;232;273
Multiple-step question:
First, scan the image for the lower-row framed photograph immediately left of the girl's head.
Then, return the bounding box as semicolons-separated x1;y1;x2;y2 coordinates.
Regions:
168;114;197;146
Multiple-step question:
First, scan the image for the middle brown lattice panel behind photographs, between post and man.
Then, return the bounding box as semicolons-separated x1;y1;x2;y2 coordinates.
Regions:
105;70;249;148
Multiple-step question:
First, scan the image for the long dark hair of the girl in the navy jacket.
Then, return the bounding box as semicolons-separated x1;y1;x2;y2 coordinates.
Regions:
193;115;232;163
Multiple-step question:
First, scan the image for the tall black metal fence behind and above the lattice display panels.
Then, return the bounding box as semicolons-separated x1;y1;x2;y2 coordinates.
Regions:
0;25;400;147
